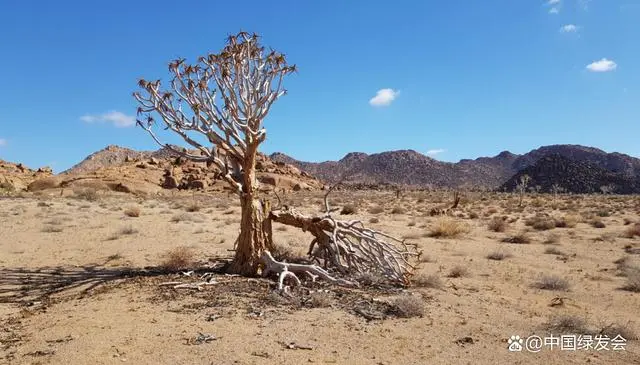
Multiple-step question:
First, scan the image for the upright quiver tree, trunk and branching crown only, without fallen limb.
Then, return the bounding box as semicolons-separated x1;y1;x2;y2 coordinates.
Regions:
133;32;295;275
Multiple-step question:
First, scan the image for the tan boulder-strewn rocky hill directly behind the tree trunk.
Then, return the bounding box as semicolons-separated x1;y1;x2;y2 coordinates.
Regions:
18;146;322;194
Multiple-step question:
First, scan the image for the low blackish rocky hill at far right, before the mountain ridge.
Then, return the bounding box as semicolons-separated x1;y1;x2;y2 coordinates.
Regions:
500;154;640;194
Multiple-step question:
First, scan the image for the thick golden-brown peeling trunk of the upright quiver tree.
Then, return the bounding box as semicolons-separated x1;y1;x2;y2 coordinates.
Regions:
229;141;273;276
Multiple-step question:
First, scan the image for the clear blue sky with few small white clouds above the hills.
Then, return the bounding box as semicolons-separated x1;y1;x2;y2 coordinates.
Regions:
0;0;640;171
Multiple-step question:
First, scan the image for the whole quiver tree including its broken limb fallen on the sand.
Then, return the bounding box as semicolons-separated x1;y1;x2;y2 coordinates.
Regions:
133;32;417;286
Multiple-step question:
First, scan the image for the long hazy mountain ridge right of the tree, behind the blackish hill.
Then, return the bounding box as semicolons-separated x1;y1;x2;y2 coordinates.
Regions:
270;145;640;191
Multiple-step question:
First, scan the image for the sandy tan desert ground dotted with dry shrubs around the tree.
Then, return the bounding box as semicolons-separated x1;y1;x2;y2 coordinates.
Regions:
0;190;640;364
